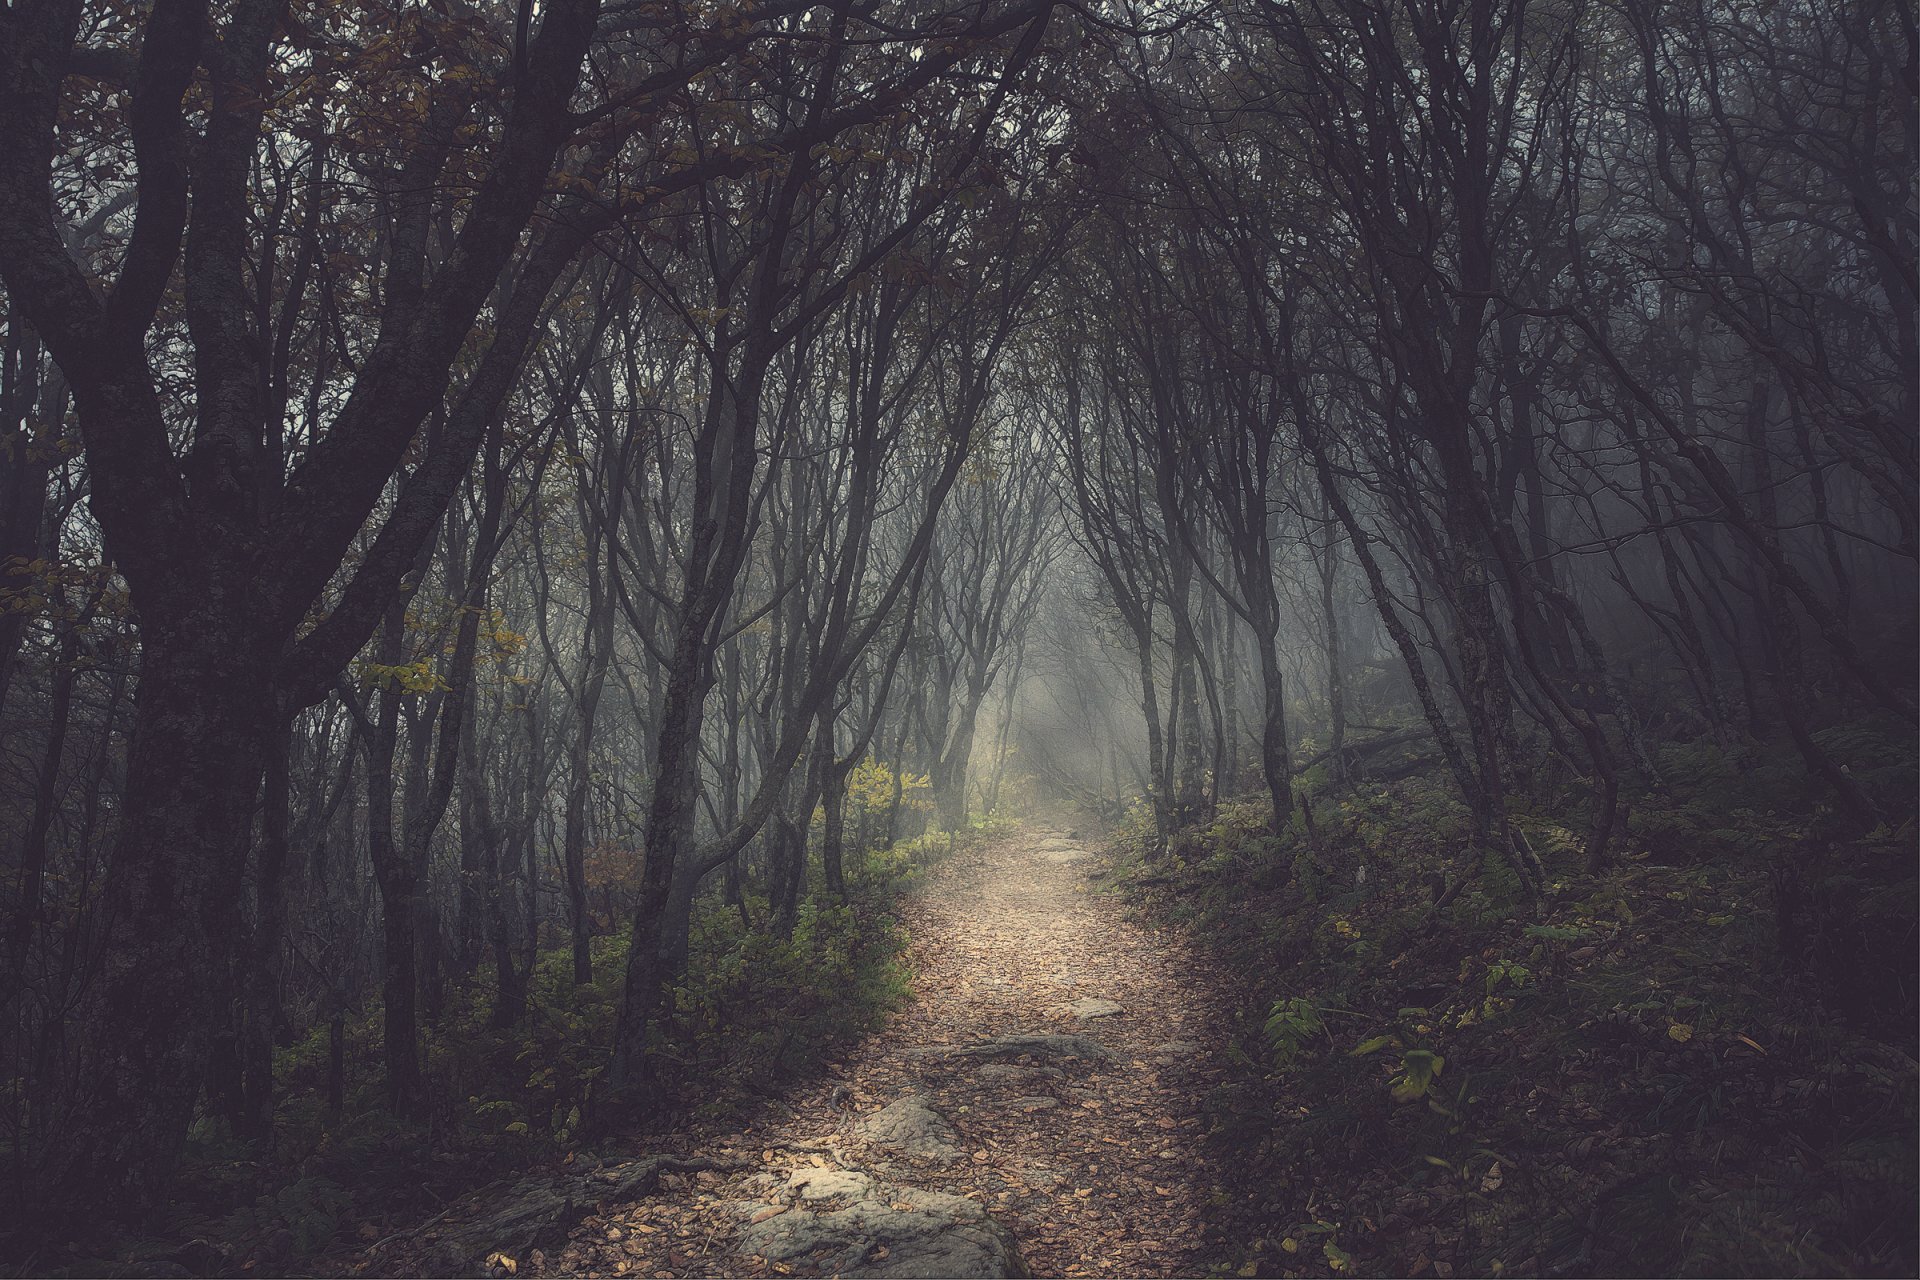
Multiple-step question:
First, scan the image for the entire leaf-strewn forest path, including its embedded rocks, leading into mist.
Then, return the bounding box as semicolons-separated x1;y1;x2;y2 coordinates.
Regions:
520;821;1231;1276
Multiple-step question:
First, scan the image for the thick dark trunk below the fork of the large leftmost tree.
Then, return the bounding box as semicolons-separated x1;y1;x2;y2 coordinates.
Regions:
35;629;276;1217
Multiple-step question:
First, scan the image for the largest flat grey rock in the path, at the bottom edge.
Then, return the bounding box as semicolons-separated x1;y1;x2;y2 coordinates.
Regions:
735;1169;1027;1278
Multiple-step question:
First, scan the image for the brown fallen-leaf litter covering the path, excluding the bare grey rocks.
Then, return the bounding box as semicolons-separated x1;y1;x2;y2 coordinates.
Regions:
355;825;1233;1276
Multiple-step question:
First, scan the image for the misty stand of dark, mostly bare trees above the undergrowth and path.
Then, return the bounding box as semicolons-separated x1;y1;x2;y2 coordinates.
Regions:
0;0;1920;1251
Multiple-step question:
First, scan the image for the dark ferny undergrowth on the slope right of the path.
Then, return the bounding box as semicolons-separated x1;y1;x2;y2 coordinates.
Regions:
1119;727;1920;1276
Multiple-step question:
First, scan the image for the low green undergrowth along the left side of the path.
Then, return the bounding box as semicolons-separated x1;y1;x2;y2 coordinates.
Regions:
6;837;975;1276
